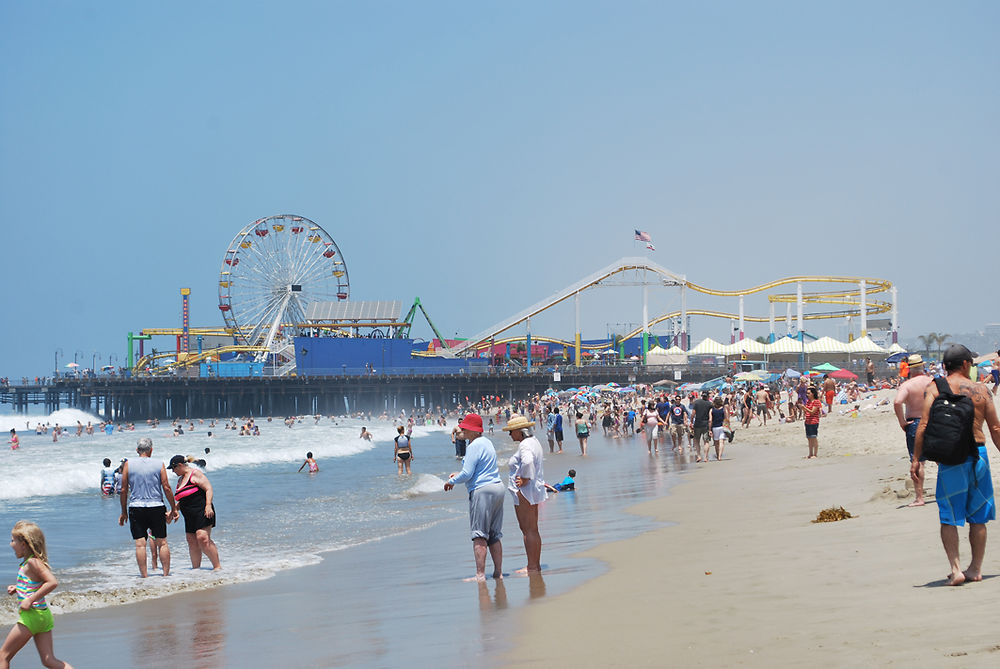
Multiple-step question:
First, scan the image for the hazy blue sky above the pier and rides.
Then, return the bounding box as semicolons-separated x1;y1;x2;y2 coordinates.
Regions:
0;0;1000;378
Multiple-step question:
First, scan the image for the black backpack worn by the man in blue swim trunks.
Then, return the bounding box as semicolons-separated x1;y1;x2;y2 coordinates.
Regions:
923;377;979;465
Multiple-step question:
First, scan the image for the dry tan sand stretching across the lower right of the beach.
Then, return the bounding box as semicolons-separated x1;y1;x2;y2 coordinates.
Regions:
504;391;1000;668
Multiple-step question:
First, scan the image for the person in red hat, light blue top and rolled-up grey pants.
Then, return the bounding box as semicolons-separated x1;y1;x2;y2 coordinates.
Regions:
444;413;504;581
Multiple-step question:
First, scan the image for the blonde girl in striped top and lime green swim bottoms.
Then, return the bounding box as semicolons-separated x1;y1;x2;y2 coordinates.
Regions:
0;520;73;669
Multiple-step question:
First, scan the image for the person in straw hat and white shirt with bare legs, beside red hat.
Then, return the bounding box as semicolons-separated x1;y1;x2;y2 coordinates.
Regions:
503;413;548;574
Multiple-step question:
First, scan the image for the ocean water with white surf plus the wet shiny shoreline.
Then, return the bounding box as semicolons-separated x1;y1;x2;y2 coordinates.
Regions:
0;410;688;667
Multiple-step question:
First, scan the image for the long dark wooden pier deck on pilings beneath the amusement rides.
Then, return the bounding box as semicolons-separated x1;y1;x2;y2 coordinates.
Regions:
0;365;723;421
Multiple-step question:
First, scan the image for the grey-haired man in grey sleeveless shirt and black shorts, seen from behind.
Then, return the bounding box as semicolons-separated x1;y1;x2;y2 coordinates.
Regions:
118;437;179;578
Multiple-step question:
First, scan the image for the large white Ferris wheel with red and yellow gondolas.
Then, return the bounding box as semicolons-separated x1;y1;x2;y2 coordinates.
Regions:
219;214;350;360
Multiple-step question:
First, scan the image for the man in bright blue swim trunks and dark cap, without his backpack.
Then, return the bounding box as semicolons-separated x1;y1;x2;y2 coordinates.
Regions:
910;344;1000;585
